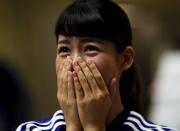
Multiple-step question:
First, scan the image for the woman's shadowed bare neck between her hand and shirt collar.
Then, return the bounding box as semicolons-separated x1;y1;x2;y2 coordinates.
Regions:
107;88;124;125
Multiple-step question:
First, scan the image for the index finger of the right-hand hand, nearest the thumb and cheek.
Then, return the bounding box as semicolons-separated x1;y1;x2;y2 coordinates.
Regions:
88;61;107;90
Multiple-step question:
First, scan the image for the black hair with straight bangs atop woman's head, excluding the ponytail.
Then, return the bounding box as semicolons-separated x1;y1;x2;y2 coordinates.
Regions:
55;0;132;50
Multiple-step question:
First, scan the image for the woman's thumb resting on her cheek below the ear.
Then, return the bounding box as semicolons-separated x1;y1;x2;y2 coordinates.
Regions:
108;77;117;99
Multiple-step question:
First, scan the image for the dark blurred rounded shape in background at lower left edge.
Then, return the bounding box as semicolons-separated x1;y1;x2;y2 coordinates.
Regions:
0;61;31;131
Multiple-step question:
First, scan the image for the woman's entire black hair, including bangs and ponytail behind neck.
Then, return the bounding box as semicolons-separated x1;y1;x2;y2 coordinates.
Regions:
55;0;142;113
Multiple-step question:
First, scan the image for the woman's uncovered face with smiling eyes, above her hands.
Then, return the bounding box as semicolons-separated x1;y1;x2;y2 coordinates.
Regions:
56;35;123;86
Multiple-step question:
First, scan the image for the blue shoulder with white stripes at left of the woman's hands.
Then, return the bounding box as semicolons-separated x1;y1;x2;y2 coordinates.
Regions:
16;110;65;131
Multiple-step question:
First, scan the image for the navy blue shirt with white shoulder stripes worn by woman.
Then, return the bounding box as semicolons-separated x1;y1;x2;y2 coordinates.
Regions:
16;110;175;131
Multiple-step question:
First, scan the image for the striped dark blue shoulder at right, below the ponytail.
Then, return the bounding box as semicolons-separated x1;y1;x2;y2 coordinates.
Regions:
123;111;175;131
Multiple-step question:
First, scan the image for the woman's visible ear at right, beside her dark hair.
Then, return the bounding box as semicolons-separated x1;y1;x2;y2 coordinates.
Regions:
121;46;135;70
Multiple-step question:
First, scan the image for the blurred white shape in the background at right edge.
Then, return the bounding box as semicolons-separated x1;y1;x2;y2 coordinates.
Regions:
150;37;180;130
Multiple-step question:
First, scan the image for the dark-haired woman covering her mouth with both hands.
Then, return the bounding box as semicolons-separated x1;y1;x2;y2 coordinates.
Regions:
17;0;172;131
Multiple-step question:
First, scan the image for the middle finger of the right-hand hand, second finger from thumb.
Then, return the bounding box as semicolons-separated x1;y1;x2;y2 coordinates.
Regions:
78;59;99;92
